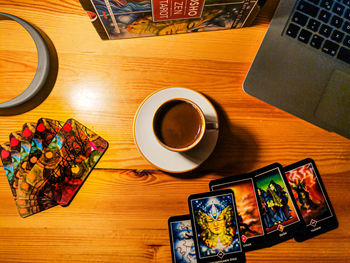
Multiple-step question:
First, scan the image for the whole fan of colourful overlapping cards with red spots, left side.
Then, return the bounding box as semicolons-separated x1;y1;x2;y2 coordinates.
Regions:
0;118;108;217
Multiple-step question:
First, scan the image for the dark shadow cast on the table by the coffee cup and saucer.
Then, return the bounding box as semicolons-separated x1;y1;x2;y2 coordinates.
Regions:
170;98;259;179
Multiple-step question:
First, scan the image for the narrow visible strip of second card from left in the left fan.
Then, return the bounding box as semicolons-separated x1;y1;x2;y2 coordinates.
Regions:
10;131;22;194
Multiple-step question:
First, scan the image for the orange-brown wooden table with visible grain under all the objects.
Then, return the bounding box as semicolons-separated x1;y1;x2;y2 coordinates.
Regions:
0;0;350;262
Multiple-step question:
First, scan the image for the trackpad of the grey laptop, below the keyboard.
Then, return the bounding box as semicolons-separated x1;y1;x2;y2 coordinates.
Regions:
315;70;350;136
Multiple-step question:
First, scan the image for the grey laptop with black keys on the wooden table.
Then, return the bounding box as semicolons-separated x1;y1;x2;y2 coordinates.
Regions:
243;0;350;139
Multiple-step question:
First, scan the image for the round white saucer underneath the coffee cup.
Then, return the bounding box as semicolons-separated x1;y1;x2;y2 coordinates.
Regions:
134;88;219;173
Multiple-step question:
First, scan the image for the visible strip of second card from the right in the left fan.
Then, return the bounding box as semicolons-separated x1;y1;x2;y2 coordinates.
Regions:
26;118;64;171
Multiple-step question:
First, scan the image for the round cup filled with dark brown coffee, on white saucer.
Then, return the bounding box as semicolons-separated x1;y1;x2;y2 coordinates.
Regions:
153;99;205;151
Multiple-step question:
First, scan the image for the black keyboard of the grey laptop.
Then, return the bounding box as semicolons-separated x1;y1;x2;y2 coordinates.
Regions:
286;0;350;64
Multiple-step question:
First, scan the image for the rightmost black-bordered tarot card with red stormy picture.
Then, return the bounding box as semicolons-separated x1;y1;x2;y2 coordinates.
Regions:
284;159;338;241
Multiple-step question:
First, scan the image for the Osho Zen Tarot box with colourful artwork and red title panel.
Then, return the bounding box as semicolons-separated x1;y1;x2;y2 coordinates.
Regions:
79;0;260;40
